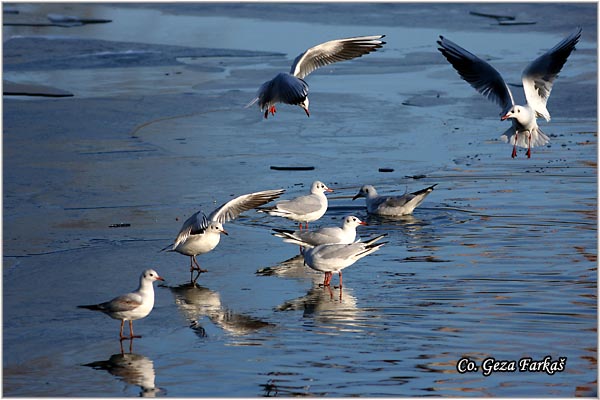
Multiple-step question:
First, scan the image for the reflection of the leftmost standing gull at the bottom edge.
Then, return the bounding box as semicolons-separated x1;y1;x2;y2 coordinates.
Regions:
83;340;163;397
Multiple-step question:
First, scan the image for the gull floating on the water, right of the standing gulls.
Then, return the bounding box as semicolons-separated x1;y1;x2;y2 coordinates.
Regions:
352;183;437;217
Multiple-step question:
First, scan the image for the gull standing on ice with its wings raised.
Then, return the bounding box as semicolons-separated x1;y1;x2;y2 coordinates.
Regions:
163;189;285;283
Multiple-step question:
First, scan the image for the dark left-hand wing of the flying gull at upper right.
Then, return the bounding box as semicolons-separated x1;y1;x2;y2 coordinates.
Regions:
437;36;514;112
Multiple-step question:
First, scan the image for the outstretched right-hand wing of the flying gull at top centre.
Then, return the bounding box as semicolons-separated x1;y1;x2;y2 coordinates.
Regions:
290;35;385;78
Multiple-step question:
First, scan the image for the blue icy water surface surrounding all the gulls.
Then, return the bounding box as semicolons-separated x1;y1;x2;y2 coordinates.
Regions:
3;4;597;397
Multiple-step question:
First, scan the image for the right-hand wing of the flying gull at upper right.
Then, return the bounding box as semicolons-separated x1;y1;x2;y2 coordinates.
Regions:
522;28;581;121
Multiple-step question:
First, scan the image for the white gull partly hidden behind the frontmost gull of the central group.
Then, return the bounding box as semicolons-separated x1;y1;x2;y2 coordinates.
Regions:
273;215;367;246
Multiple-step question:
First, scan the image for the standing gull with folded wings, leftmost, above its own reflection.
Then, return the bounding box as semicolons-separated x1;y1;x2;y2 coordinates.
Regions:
78;269;164;340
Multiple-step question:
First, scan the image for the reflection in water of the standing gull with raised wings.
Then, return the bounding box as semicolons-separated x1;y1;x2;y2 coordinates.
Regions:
170;283;272;337
